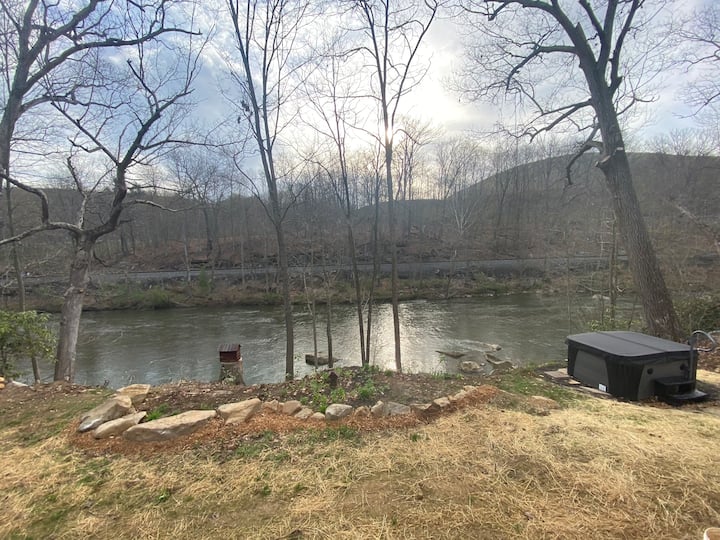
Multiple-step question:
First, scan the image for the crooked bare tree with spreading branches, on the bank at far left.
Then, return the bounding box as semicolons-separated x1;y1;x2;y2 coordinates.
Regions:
0;1;197;380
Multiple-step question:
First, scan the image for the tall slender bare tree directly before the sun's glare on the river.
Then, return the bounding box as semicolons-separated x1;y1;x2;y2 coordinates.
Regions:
353;0;439;371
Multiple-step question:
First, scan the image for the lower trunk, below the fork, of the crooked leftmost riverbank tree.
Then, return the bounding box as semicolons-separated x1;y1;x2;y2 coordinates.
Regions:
54;238;95;382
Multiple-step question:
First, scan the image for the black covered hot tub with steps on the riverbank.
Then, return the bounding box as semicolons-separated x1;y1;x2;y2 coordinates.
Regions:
567;332;701;401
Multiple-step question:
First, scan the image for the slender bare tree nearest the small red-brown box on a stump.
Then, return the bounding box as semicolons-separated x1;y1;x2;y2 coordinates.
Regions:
227;0;309;379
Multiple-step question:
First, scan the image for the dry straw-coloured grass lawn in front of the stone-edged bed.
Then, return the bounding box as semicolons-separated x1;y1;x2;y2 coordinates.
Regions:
0;372;720;539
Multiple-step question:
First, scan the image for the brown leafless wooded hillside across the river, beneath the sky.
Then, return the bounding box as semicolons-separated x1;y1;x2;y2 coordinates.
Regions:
3;153;720;280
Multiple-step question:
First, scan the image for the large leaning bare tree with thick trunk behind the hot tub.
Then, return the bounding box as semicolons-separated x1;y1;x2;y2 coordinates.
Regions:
464;0;680;338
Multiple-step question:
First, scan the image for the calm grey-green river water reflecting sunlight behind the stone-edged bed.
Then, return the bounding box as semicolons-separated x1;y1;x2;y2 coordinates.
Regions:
33;294;616;388
